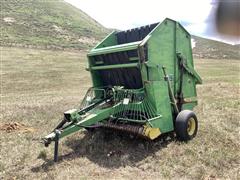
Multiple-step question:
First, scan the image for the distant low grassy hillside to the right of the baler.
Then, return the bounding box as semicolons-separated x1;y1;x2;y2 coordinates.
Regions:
192;36;240;60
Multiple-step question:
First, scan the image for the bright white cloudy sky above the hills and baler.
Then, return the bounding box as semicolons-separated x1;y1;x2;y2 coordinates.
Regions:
65;0;240;43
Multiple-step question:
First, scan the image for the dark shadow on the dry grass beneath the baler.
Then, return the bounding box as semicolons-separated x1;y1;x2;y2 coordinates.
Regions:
32;130;175;172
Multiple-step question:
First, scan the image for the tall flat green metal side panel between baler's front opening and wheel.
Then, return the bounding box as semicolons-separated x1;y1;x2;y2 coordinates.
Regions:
146;20;175;132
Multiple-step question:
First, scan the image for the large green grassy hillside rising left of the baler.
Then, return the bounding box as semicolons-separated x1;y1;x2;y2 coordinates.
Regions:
0;0;108;49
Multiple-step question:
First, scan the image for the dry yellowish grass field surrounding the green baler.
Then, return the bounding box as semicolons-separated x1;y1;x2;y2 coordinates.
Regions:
0;47;240;179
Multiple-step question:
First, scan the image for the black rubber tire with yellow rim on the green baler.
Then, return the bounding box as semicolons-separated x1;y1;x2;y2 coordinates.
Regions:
175;110;198;141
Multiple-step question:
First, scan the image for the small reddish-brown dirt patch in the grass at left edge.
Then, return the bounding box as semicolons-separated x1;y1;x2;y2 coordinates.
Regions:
0;122;35;133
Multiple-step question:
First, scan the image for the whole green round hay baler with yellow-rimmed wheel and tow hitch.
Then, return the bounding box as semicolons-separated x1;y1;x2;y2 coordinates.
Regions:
44;19;201;161
